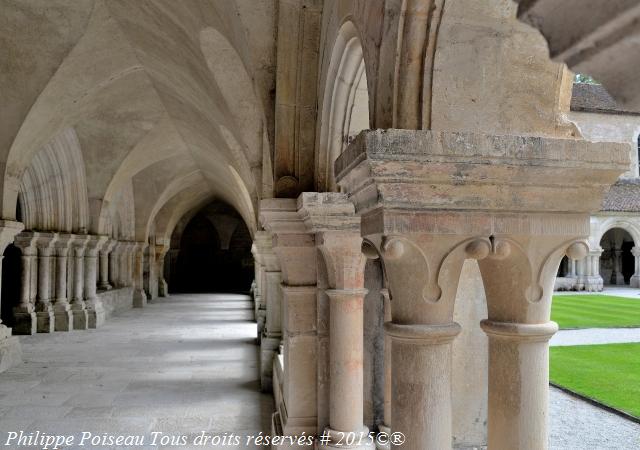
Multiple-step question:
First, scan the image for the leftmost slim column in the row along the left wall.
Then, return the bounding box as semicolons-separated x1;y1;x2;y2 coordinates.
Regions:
13;232;38;334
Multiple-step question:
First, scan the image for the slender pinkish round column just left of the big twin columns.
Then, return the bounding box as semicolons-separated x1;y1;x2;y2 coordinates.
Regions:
316;230;375;449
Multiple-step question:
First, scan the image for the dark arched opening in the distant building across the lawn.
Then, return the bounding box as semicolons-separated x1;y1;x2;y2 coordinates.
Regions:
600;228;635;286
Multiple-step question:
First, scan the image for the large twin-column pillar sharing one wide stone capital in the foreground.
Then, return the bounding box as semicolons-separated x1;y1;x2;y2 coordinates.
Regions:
332;129;628;450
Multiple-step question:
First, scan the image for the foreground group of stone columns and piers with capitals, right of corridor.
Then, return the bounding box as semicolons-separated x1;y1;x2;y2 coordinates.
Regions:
254;130;627;450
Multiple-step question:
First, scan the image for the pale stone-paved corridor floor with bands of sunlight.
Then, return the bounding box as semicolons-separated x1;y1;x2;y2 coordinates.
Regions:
0;294;274;449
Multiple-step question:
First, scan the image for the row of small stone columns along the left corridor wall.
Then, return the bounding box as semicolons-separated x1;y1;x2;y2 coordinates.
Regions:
4;231;166;334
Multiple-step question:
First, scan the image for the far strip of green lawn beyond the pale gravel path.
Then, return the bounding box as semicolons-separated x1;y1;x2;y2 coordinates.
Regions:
551;294;640;328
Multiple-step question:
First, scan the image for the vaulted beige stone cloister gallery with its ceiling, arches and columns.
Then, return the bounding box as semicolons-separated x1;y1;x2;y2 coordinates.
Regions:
0;0;640;450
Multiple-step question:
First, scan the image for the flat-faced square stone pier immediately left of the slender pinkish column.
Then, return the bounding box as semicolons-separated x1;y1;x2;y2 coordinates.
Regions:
260;199;317;436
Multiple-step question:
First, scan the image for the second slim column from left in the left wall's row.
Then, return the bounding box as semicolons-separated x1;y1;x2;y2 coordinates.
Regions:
34;233;58;333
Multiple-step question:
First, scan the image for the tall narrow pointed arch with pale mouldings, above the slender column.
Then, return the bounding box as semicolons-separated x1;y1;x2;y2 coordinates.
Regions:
316;22;369;191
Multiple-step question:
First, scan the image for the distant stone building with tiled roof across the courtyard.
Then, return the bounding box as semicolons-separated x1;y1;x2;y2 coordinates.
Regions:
555;83;640;291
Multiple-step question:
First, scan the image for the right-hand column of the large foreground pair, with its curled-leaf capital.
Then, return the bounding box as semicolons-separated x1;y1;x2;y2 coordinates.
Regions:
480;237;588;450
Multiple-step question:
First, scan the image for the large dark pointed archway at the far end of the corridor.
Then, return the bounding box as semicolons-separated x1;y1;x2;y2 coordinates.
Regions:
165;202;253;293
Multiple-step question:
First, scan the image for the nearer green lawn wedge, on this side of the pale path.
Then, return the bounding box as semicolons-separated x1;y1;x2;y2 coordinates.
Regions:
549;343;640;417
